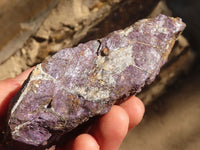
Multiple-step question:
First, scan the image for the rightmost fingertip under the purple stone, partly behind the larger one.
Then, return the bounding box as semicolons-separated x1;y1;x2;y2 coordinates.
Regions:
120;96;145;130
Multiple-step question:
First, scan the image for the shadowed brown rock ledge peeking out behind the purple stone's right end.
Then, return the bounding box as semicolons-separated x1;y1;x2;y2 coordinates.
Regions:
136;1;196;106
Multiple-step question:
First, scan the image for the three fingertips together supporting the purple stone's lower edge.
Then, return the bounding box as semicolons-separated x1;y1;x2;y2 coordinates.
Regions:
58;96;144;150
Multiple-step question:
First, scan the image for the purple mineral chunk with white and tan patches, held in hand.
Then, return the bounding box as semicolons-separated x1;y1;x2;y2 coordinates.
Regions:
6;15;185;149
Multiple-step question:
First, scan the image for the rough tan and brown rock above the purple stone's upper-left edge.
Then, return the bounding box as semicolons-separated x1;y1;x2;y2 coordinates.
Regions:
0;0;159;80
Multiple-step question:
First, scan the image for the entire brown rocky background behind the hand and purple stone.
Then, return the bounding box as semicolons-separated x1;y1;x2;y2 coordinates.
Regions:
0;0;200;150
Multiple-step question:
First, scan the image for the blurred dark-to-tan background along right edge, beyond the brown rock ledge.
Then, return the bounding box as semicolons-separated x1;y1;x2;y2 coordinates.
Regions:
121;0;200;150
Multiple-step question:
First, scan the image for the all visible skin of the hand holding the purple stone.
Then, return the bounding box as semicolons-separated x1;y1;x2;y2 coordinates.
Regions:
0;68;145;150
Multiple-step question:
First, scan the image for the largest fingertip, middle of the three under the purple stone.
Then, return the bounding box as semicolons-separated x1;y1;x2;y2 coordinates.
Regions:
91;105;129;150
